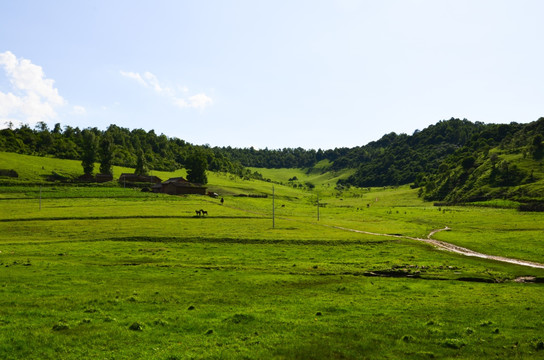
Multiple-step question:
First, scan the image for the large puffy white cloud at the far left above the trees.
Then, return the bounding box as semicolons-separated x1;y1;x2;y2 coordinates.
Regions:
0;51;66;124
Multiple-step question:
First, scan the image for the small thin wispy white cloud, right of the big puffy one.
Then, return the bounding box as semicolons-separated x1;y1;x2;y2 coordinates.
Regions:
120;70;213;109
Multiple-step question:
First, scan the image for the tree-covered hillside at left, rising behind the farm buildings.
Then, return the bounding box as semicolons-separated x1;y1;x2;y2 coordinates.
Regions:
0;122;256;176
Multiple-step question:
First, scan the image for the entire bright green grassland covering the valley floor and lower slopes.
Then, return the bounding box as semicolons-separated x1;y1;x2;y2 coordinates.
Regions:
0;153;544;359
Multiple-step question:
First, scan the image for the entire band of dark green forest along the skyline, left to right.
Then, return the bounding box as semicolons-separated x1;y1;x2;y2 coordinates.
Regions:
0;118;544;203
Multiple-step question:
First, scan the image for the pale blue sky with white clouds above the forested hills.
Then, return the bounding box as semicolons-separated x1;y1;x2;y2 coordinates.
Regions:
0;0;544;149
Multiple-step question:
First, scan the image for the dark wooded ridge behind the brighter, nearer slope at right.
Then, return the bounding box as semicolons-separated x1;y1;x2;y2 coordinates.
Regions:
222;118;542;195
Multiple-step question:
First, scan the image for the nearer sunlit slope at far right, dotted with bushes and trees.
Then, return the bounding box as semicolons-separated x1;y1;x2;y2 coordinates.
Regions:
416;118;544;205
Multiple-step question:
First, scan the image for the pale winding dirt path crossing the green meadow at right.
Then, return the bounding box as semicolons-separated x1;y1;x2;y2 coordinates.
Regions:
325;225;544;269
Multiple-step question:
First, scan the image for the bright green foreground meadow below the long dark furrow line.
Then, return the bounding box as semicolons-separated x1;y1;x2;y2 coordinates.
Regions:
0;239;544;359
